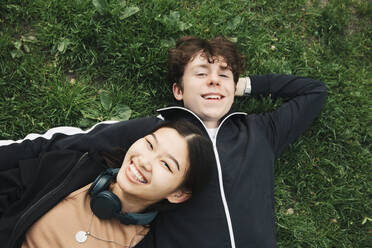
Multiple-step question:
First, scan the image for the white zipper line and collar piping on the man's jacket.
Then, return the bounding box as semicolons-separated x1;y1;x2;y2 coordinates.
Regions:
158;106;247;248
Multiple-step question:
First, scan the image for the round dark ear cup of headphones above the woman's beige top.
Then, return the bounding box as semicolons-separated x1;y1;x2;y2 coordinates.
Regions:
90;190;121;219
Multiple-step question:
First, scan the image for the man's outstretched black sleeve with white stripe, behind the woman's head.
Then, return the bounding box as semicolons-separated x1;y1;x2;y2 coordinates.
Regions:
0;117;161;171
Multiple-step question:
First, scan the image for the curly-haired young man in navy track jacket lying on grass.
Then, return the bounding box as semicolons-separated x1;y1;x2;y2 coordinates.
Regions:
0;37;326;248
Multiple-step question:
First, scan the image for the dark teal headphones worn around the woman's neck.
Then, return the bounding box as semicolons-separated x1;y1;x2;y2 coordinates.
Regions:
88;168;157;225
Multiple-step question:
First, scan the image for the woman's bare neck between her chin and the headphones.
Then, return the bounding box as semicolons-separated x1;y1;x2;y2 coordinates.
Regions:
111;183;151;213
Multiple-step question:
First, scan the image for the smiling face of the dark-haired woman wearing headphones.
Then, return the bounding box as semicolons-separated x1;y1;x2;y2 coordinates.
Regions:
116;127;189;207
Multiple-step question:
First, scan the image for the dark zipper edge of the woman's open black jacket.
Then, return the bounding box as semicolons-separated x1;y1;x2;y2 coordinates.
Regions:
9;152;88;248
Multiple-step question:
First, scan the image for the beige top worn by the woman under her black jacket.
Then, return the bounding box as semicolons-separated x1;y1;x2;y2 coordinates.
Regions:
22;184;149;248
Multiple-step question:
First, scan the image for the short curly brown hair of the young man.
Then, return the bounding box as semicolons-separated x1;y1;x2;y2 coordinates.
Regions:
168;36;245;89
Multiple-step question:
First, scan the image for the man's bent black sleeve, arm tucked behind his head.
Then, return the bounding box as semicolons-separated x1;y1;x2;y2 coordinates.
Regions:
250;74;327;156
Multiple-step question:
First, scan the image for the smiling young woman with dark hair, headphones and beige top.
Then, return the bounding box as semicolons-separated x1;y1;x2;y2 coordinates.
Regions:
0;121;215;248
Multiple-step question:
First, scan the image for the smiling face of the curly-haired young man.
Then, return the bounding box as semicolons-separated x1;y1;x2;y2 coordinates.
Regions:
173;53;235;128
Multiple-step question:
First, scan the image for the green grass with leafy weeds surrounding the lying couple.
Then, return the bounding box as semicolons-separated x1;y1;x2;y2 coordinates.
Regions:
0;0;372;248
